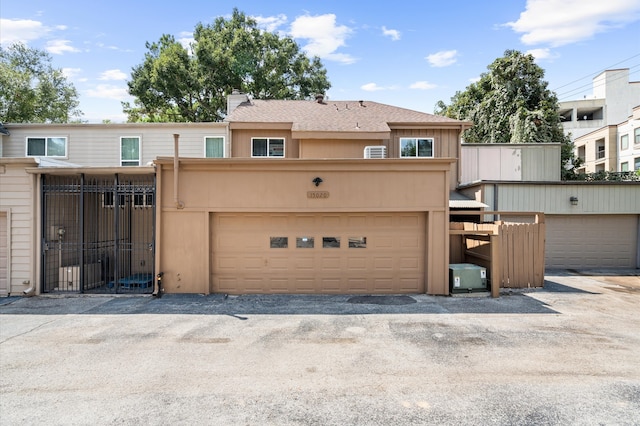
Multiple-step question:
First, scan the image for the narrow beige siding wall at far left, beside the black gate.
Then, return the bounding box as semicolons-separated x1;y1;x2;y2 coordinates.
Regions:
0;159;35;294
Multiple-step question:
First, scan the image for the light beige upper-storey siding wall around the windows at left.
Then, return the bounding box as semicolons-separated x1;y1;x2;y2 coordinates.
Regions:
4;123;227;167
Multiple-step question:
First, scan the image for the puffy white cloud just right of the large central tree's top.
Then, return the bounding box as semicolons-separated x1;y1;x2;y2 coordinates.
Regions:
290;14;356;64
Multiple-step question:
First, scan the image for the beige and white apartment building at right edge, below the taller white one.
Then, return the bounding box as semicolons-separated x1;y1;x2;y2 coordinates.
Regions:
574;105;640;173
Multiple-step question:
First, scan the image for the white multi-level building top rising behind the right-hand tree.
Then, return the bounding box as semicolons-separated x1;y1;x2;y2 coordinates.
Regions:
559;68;640;140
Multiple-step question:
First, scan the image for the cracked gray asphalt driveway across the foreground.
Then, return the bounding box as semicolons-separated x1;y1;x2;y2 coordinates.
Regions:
0;271;640;425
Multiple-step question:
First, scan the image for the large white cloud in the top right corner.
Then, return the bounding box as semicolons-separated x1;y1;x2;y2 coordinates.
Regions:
505;0;640;47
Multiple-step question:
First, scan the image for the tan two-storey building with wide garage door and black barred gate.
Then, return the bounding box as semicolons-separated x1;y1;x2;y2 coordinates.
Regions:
0;94;469;294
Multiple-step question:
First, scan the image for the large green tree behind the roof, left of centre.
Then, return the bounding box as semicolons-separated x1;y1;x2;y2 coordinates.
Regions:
123;9;331;122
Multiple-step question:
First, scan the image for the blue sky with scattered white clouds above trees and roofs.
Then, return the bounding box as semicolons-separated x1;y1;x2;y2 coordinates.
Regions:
0;0;640;122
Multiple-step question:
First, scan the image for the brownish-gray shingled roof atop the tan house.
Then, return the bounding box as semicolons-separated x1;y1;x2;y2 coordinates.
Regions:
225;100;469;132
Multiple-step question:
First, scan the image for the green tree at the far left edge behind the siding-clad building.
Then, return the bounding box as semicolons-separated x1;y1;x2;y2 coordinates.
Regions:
0;43;82;123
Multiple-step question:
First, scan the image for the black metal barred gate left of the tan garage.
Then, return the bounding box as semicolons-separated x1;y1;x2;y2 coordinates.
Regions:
42;174;156;293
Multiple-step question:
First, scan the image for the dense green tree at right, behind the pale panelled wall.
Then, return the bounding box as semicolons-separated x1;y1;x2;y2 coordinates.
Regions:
435;50;577;178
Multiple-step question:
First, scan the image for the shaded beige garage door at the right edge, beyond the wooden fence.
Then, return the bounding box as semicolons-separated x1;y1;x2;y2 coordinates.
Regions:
545;215;638;268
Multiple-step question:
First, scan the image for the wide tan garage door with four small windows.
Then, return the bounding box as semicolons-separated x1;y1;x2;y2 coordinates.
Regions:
211;213;426;294
